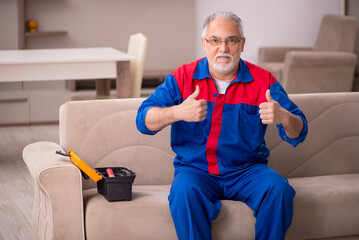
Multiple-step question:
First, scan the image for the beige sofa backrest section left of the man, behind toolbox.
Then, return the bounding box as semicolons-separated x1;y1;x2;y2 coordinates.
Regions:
60;99;174;189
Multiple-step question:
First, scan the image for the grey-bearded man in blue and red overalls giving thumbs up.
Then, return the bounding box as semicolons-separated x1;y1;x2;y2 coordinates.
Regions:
136;12;308;240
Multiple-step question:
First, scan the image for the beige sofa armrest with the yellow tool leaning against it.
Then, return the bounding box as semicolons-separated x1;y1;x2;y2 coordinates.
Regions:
23;142;85;239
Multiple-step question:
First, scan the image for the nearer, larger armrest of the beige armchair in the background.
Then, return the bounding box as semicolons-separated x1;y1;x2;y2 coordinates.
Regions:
282;51;357;93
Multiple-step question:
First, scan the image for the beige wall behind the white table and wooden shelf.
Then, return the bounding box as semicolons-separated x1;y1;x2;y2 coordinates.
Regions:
0;0;195;70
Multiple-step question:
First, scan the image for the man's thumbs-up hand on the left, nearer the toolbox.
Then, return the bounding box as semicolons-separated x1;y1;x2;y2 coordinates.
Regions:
175;86;207;122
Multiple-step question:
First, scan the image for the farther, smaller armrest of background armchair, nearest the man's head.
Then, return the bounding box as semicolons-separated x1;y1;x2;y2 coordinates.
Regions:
258;47;311;65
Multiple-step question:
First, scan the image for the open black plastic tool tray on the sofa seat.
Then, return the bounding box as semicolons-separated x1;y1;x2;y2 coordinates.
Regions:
95;167;136;202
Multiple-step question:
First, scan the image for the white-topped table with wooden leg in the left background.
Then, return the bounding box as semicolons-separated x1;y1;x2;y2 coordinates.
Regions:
0;48;135;98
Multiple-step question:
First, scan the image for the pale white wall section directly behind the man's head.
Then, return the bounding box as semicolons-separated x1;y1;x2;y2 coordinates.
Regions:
195;0;342;63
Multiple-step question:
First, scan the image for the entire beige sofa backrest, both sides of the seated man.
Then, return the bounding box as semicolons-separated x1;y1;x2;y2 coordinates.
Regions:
60;92;359;189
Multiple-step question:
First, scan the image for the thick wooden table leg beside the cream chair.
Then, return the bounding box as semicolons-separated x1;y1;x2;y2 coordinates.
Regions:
116;61;131;98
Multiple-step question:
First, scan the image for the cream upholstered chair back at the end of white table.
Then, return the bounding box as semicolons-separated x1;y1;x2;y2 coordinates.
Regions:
127;33;148;98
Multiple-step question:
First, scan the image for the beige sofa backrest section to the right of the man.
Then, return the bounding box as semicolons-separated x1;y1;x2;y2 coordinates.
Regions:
266;92;359;177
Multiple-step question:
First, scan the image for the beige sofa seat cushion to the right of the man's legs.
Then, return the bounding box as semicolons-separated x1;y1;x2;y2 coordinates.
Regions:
286;173;359;239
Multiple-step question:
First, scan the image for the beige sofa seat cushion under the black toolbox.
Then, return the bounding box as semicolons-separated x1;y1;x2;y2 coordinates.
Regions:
84;185;255;240
